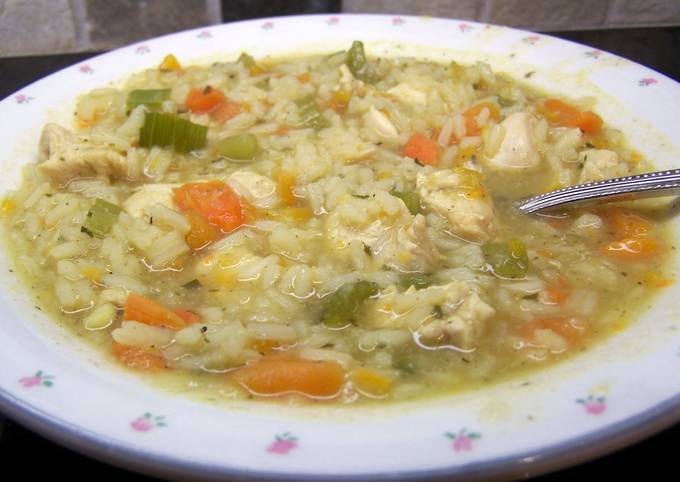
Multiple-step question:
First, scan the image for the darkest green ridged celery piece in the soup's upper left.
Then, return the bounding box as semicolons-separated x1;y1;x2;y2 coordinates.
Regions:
139;112;208;152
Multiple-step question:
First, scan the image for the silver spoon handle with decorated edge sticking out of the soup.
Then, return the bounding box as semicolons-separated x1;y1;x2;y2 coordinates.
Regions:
517;169;680;214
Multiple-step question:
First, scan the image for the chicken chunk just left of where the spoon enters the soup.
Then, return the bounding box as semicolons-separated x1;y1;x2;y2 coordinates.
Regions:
416;169;496;241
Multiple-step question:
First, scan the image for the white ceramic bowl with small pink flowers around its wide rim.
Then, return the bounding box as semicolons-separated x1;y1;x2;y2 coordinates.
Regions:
0;15;680;480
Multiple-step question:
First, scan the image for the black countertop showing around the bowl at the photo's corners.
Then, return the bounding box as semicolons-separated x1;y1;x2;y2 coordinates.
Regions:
0;28;680;482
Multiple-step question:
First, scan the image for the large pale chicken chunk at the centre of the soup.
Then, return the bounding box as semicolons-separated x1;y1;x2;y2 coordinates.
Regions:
326;192;439;272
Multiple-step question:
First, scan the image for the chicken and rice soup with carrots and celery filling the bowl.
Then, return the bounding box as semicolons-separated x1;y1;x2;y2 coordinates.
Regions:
2;42;673;403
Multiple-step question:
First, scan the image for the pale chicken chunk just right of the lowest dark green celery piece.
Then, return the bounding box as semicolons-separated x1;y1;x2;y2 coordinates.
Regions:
362;281;495;350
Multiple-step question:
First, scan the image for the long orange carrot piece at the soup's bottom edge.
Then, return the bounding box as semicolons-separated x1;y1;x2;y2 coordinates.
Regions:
232;355;345;398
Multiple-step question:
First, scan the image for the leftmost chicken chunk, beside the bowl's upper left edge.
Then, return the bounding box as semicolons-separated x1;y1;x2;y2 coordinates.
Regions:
40;123;129;184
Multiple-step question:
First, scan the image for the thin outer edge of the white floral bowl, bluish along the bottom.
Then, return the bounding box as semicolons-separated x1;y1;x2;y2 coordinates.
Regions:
0;13;680;482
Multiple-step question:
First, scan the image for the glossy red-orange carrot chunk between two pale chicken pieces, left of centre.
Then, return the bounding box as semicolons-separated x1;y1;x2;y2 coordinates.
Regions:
173;181;245;233
